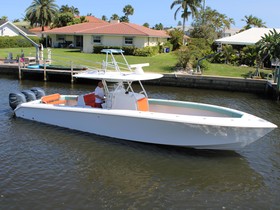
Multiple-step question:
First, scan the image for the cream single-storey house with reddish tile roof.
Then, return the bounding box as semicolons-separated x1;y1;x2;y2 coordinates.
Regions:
44;17;169;53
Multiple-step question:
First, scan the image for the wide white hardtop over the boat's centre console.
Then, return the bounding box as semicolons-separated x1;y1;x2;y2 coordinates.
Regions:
73;70;163;82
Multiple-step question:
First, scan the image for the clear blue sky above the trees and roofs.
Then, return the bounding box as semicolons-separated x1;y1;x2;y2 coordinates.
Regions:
0;0;280;28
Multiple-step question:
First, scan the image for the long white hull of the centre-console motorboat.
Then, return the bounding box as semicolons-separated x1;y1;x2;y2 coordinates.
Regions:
15;102;276;150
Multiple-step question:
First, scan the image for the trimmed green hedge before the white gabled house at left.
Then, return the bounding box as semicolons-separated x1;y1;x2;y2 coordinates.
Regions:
0;36;40;48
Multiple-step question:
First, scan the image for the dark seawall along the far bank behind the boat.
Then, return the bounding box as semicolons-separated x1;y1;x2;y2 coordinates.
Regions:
0;65;275;94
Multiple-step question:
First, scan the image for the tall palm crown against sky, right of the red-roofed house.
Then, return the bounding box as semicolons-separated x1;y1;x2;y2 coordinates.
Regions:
170;0;202;31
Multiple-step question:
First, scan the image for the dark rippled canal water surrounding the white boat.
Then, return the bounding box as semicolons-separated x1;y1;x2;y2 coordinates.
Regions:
0;75;280;210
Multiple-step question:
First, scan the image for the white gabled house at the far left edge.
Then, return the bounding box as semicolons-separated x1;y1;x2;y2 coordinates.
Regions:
0;20;35;36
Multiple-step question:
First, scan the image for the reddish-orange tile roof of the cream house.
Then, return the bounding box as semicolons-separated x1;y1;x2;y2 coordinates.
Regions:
45;21;169;38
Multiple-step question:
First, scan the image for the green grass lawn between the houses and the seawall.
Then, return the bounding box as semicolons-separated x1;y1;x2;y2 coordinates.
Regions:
0;47;271;78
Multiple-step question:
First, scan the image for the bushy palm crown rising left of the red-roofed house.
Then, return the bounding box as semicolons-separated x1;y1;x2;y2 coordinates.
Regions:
25;0;58;31
